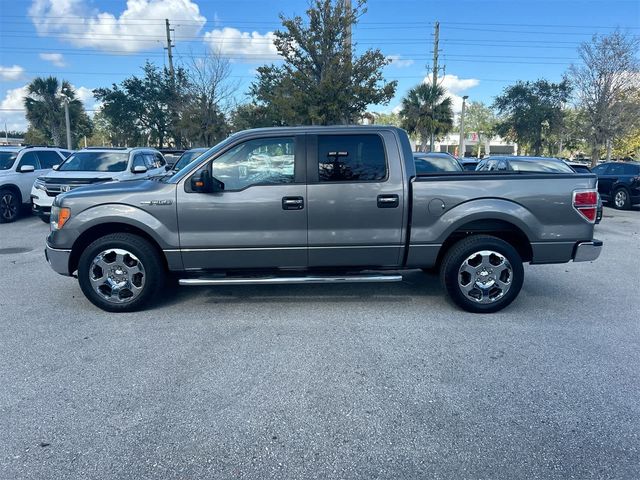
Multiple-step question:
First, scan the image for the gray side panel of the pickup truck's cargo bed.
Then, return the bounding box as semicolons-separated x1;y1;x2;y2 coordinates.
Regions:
408;173;596;265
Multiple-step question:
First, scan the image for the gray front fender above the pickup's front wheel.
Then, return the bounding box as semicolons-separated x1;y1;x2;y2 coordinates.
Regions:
49;203;180;250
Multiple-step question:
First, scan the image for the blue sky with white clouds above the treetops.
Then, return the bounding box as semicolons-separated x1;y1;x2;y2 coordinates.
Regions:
0;0;640;129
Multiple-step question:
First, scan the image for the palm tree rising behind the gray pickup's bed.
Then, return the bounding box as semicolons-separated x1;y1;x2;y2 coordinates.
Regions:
400;83;453;149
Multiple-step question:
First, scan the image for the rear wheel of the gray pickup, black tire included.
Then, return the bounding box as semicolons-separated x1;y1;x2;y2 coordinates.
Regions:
440;235;524;313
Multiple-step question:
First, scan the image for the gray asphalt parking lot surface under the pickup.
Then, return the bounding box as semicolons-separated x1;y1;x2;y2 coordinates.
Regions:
0;208;640;479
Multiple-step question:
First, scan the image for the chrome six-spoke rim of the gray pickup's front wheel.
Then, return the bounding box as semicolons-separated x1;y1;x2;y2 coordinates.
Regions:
89;248;146;303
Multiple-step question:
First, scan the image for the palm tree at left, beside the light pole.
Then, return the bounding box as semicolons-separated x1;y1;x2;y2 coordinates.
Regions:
24;77;84;145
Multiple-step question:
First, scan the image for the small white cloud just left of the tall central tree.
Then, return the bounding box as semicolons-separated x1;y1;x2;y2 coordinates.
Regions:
204;27;280;62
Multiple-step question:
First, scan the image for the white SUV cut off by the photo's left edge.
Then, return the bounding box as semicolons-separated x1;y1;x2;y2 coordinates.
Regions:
0;146;71;223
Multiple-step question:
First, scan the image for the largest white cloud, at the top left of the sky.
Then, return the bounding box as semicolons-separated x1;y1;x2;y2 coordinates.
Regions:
29;0;207;53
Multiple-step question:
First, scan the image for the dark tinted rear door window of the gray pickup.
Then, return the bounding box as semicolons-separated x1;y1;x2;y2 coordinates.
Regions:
318;134;387;182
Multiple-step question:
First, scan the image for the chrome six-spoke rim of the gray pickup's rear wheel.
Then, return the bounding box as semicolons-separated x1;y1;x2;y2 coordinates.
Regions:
458;250;513;304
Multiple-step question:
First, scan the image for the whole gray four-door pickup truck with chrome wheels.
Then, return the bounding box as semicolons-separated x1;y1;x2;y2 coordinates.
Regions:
46;126;602;312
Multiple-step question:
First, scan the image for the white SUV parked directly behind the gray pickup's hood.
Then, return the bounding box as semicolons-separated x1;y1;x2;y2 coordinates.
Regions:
31;147;167;222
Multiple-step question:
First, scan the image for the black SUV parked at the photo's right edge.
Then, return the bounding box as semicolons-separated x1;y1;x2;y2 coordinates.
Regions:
591;162;640;210
